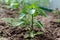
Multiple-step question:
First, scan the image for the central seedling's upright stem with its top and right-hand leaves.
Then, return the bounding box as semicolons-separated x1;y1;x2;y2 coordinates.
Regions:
20;3;47;38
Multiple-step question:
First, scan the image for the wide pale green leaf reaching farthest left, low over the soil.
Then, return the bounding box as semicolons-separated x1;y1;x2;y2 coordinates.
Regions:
1;18;24;26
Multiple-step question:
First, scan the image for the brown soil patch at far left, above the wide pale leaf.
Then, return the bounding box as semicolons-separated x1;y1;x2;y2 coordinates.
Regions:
0;4;19;18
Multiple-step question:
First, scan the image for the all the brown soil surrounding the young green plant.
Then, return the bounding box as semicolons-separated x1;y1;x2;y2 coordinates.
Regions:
0;5;60;40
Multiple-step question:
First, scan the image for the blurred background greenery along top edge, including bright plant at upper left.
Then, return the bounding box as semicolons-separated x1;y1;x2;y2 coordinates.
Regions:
0;0;50;9
